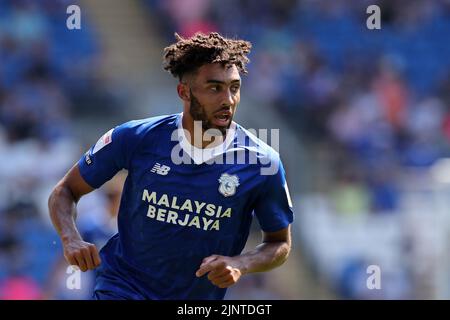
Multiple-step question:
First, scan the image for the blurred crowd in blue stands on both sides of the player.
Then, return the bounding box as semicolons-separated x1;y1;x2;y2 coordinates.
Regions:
0;0;450;299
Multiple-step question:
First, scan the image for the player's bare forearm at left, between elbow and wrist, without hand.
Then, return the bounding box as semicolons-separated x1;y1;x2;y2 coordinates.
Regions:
48;184;81;242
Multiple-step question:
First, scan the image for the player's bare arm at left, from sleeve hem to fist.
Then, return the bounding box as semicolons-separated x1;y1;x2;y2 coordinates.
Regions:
48;164;101;272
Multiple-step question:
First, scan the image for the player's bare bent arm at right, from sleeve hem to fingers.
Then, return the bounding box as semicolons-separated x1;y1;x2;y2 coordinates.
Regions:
196;225;291;288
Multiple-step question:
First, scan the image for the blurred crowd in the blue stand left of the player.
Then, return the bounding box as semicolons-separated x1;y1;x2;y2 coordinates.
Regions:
0;0;120;299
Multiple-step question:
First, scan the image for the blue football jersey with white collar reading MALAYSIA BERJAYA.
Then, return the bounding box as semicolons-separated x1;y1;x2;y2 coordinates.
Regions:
78;113;293;300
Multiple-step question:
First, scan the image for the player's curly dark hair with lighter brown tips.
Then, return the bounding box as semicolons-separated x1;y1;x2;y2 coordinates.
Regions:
163;32;252;81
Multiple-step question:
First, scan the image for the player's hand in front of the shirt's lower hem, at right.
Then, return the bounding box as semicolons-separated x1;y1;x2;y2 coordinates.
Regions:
195;255;242;288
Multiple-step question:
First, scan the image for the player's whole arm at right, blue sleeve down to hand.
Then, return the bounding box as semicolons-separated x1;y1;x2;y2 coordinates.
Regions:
196;157;293;288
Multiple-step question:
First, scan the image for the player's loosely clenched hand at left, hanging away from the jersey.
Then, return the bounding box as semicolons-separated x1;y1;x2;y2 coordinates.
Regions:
63;239;102;272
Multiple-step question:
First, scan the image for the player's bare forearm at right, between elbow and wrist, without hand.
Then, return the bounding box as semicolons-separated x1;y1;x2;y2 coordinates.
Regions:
237;241;291;274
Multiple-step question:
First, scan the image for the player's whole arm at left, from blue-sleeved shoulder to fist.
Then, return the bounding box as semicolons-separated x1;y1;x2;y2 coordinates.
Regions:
48;120;147;271
